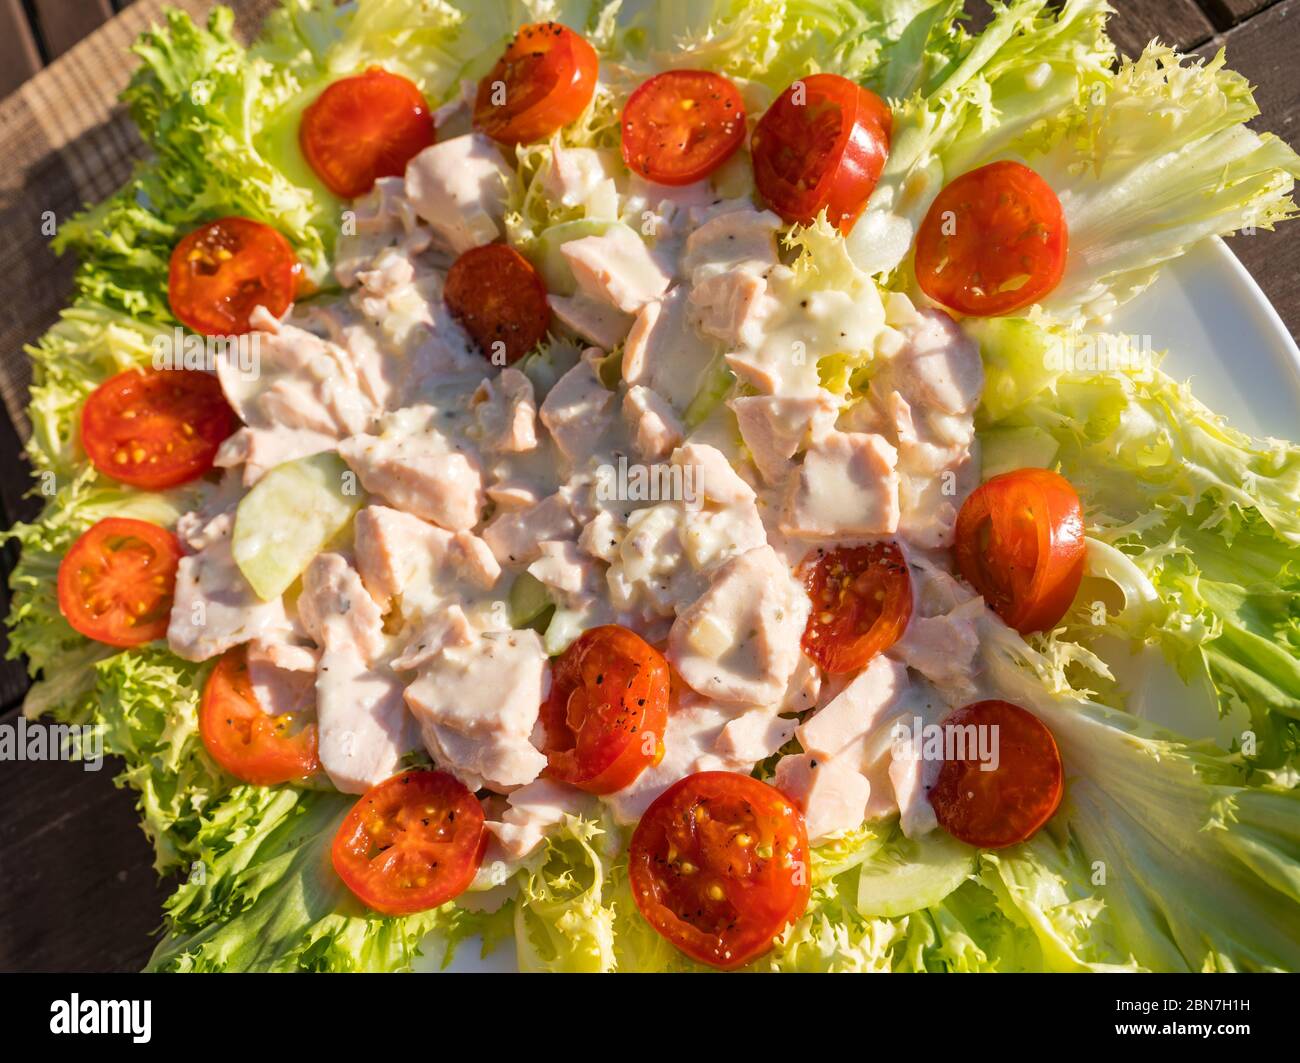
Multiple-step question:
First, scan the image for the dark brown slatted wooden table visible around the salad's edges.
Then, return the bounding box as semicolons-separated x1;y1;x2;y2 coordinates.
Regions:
0;0;1300;971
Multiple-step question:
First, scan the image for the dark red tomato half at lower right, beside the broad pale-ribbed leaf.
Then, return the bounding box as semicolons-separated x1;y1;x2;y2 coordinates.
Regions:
930;700;1062;849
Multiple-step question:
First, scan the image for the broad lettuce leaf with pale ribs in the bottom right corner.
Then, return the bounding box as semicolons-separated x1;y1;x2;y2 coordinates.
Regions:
980;617;1300;971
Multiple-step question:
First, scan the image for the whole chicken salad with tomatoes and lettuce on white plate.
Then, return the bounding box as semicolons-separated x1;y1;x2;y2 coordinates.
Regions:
9;0;1300;972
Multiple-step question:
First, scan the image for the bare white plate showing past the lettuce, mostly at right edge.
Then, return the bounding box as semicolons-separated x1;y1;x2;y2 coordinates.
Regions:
417;237;1300;972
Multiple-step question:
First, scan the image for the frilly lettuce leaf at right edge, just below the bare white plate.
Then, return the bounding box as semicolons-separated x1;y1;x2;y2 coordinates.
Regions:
969;318;1300;768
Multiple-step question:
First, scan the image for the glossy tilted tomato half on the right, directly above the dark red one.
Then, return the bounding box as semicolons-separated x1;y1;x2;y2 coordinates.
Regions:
954;469;1087;634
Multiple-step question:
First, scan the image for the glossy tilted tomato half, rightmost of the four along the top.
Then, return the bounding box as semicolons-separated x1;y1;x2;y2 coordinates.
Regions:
750;74;893;233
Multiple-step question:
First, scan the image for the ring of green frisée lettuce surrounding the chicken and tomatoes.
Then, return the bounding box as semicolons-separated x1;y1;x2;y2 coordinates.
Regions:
9;0;1300;972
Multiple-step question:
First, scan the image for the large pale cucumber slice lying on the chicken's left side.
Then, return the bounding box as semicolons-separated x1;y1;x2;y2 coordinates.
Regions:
230;454;363;600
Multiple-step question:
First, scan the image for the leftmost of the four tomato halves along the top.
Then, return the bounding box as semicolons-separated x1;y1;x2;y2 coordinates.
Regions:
298;66;434;199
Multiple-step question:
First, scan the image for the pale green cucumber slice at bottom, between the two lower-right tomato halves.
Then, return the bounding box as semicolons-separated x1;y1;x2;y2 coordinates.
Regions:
858;829;978;919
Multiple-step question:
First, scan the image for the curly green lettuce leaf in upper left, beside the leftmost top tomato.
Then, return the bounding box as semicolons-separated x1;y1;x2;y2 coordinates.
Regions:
55;6;338;322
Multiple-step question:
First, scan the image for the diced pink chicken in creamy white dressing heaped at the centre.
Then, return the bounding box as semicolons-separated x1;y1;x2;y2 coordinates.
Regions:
169;124;984;852
